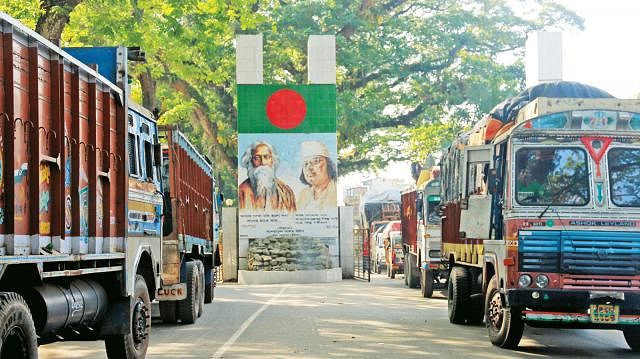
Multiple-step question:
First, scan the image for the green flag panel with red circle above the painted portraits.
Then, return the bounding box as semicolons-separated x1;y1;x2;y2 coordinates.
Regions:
238;85;336;133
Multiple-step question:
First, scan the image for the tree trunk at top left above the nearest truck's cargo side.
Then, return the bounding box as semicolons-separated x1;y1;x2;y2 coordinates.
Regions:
36;0;82;45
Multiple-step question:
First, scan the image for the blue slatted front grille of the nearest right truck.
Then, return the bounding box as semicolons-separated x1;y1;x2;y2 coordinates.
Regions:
518;231;640;275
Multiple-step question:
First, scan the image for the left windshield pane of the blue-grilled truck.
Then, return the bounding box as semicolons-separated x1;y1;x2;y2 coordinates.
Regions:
514;147;589;206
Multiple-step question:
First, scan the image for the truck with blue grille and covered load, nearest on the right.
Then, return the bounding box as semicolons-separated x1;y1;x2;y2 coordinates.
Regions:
441;82;640;351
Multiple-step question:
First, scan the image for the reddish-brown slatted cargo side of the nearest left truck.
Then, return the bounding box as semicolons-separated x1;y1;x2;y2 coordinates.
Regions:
0;18;127;257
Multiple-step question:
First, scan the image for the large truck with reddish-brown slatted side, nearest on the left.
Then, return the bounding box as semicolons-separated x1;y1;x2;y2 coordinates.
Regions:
0;13;219;358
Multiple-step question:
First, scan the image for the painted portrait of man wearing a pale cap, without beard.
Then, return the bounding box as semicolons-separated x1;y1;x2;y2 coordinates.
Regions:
296;141;338;209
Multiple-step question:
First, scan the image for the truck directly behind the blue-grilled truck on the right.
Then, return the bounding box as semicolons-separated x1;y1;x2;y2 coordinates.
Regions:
401;166;449;298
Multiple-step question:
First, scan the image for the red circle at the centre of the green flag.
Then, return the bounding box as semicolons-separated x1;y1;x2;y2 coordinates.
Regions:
266;89;307;130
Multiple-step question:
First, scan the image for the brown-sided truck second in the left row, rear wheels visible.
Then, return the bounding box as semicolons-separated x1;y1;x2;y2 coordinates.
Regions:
157;125;220;324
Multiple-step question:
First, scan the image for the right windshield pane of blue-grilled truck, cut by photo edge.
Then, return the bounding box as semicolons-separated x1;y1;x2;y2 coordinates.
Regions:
607;148;640;207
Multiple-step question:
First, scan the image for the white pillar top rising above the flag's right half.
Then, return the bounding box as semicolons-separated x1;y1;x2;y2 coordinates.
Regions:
307;35;336;84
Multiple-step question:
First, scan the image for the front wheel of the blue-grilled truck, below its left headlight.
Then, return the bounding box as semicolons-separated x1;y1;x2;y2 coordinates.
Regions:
485;275;524;349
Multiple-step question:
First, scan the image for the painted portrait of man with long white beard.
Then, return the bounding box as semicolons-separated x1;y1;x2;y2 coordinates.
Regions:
238;141;296;212
